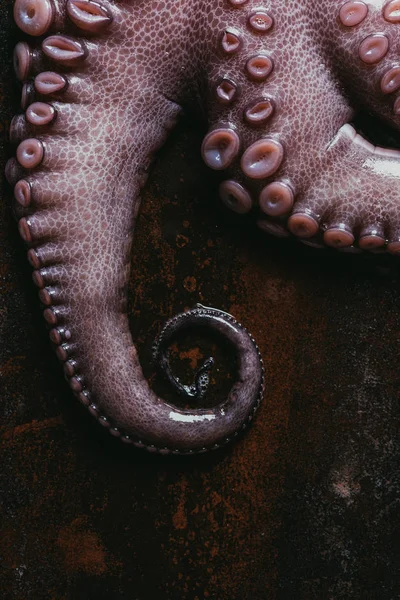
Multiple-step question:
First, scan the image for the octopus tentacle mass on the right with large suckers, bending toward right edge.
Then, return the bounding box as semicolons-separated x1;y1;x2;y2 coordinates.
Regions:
202;0;400;253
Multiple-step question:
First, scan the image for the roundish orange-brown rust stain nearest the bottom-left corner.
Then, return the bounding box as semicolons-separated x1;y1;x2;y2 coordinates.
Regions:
57;518;108;575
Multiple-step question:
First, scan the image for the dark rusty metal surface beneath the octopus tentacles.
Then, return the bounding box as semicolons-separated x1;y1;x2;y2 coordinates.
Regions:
0;3;400;600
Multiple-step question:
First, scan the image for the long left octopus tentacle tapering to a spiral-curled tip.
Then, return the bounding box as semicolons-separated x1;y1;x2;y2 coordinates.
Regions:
8;0;263;453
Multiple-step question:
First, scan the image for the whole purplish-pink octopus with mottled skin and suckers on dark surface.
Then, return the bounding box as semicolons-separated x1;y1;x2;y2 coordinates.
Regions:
6;0;400;454
